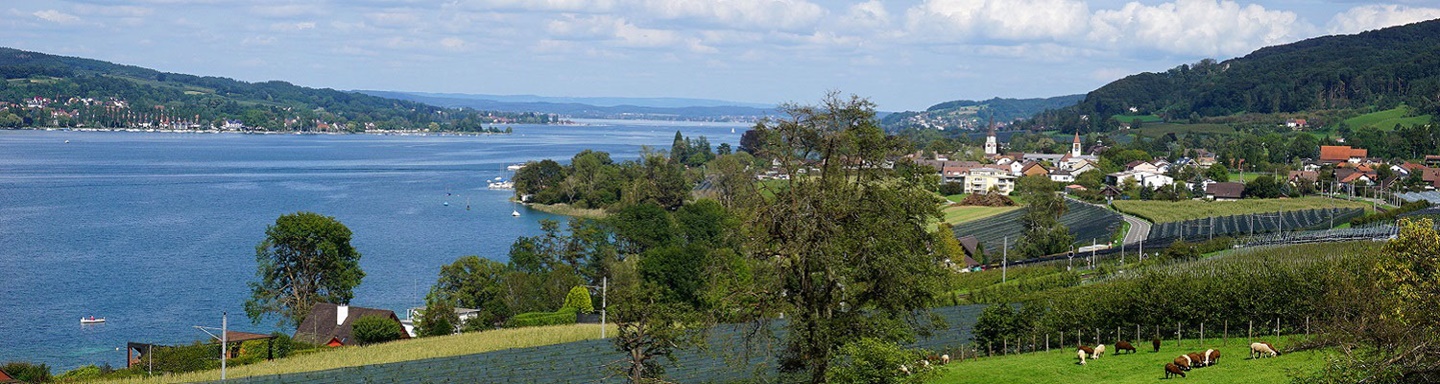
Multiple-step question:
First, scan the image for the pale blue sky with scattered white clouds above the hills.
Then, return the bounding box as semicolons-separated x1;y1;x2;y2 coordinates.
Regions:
0;0;1440;111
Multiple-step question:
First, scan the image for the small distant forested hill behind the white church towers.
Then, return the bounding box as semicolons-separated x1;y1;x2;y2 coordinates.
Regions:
881;95;1084;131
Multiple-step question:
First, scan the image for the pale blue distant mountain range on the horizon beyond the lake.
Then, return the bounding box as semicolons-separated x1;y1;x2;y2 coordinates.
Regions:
357;91;776;121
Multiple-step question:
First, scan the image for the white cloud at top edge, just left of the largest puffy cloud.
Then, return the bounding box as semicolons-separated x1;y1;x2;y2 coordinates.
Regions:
906;0;1090;42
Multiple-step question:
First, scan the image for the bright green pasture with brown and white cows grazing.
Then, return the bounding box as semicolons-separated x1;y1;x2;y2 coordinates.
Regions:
930;339;1325;384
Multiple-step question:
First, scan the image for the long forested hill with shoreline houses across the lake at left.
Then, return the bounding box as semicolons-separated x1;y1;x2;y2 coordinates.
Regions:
0;47;556;132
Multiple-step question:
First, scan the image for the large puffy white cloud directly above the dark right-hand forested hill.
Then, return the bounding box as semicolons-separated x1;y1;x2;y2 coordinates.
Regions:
1089;0;1313;56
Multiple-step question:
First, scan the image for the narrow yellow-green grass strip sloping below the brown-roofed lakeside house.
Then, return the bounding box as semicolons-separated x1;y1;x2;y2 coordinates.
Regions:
95;324;615;383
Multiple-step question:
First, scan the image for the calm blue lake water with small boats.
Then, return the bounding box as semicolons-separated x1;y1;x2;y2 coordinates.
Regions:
0;122;744;372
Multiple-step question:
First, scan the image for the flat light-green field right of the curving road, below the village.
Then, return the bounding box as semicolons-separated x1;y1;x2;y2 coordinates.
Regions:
1113;197;1371;224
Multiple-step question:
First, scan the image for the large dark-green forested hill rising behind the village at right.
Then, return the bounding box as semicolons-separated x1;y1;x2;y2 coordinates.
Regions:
1054;20;1440;131
